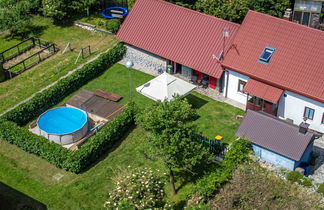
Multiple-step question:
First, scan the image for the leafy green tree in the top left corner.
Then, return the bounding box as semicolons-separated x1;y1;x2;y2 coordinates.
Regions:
0;0;31;35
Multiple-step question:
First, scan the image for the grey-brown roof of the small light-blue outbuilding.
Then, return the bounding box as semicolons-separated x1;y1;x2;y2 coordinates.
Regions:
235;110;314;161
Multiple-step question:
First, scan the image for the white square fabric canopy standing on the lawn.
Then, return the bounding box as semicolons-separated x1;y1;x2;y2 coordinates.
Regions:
136;72;196;101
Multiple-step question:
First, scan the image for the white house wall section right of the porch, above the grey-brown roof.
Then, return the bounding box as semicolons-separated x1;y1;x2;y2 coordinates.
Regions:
278;91;324;133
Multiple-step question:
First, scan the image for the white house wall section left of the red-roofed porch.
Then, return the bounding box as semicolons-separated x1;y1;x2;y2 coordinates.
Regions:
223;70;249;105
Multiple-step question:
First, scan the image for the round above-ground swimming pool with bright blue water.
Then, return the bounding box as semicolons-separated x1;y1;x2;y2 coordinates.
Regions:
37;107;88;144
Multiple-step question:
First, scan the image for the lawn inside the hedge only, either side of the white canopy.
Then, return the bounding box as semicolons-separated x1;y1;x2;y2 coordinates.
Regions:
65;64;244;141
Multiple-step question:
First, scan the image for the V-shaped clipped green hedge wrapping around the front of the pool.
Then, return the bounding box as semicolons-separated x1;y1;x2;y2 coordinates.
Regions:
0;106;134;173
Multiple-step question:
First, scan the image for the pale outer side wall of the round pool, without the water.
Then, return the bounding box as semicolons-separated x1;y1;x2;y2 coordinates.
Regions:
38;109;89;145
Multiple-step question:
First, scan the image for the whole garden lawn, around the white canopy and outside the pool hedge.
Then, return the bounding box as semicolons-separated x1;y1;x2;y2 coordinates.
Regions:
0;64;242;209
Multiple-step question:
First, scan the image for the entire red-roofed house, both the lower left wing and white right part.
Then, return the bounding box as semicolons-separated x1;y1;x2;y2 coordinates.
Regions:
117;0;324;133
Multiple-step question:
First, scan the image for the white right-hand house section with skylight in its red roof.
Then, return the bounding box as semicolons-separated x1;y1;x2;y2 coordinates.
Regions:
222;11;324;133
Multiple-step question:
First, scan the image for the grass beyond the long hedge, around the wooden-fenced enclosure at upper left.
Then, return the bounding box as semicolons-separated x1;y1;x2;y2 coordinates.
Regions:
0;16;117;113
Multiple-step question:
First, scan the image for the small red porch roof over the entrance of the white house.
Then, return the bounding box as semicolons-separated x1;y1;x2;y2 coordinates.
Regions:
244;79;283;104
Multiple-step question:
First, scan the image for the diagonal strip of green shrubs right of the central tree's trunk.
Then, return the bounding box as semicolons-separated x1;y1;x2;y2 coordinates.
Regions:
192;139;251;198
